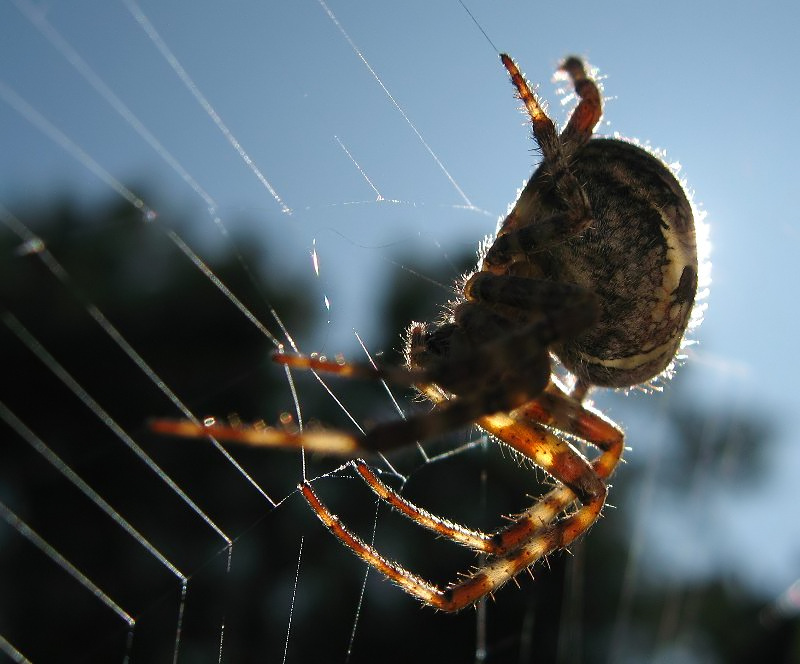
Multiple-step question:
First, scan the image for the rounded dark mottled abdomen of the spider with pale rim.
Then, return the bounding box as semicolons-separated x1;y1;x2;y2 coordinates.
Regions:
536;139;697;387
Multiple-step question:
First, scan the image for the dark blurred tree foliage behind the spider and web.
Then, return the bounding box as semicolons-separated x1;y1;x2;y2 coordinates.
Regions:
0;195;800;663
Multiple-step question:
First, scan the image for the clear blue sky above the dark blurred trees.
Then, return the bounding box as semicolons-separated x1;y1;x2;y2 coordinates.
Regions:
0;0;800;608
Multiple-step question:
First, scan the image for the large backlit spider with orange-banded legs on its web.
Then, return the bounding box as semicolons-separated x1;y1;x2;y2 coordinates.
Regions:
153;54;698;611
